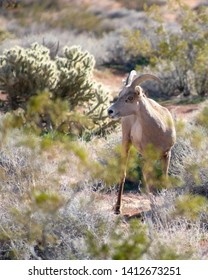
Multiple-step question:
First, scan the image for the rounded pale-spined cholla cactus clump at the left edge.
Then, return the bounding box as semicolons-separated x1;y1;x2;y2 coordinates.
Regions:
0;43;57;110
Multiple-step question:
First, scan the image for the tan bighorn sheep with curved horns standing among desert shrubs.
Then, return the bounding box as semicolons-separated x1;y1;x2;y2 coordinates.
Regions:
108;70;176;214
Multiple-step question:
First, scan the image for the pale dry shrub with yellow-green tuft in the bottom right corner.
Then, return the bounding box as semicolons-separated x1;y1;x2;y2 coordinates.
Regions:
145;188;208;260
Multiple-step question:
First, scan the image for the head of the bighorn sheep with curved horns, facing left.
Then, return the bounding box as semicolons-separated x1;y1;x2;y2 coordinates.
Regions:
108;70;161;119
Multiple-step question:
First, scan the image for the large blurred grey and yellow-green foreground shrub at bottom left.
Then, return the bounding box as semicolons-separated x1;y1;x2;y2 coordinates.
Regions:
0;128;149;259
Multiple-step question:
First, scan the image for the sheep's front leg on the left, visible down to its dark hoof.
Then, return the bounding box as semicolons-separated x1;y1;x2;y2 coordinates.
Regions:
114;141;130;214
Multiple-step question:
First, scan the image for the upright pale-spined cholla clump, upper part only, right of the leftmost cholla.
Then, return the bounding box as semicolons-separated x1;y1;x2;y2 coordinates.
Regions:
54;46;98;110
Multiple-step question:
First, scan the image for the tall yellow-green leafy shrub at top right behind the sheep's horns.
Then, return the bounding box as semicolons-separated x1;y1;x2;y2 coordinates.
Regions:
122;1;208;96
